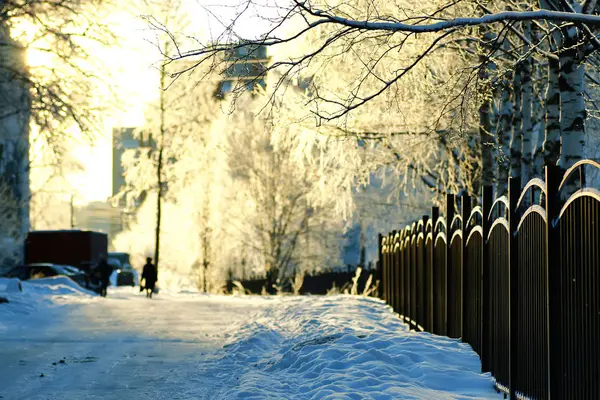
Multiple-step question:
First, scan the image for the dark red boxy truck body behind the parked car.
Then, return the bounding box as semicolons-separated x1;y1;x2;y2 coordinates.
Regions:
25;230;108;273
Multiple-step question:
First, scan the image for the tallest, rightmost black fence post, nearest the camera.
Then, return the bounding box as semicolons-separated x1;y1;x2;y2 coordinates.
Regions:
546;165;564;399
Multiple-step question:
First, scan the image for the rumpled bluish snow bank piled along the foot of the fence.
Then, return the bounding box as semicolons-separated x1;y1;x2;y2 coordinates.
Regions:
207;296;500;399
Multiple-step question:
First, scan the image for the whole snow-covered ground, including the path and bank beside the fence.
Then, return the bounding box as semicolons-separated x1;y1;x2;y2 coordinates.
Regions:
0;280;501;399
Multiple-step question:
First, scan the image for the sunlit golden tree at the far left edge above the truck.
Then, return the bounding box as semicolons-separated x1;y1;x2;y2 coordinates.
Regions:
0;0;114;262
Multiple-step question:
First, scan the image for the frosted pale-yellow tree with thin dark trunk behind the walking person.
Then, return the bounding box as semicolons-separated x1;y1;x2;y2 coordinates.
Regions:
115;67;221;288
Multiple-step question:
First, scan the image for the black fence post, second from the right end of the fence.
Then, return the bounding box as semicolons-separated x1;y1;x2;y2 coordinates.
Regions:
508;177;521;400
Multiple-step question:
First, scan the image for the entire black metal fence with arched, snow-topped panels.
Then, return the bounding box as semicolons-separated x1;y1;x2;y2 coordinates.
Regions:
378;160;600;399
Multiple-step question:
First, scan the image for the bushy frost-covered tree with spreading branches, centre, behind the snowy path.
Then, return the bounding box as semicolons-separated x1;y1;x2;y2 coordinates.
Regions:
221;94;343;291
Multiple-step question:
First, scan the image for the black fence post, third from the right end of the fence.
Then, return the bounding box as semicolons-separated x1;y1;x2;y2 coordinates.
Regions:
480;186;494;372
